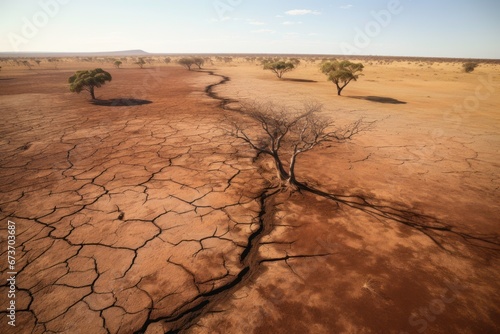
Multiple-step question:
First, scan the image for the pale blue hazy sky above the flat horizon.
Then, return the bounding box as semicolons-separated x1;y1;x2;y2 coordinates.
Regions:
0;0;500;58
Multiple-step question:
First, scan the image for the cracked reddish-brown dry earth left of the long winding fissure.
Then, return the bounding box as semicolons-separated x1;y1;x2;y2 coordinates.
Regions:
0;68;263;333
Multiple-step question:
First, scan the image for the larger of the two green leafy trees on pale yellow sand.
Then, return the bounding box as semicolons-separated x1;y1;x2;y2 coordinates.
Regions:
321;60;364;95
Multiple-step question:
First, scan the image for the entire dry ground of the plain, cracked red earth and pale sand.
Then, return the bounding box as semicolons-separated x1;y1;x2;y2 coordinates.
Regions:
0;59;500;334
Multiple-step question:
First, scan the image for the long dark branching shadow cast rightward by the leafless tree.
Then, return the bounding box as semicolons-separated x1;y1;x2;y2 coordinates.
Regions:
297;182;500;253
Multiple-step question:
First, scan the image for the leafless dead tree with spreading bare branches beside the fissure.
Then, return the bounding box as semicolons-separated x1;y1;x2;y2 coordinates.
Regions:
229;103;373;187
